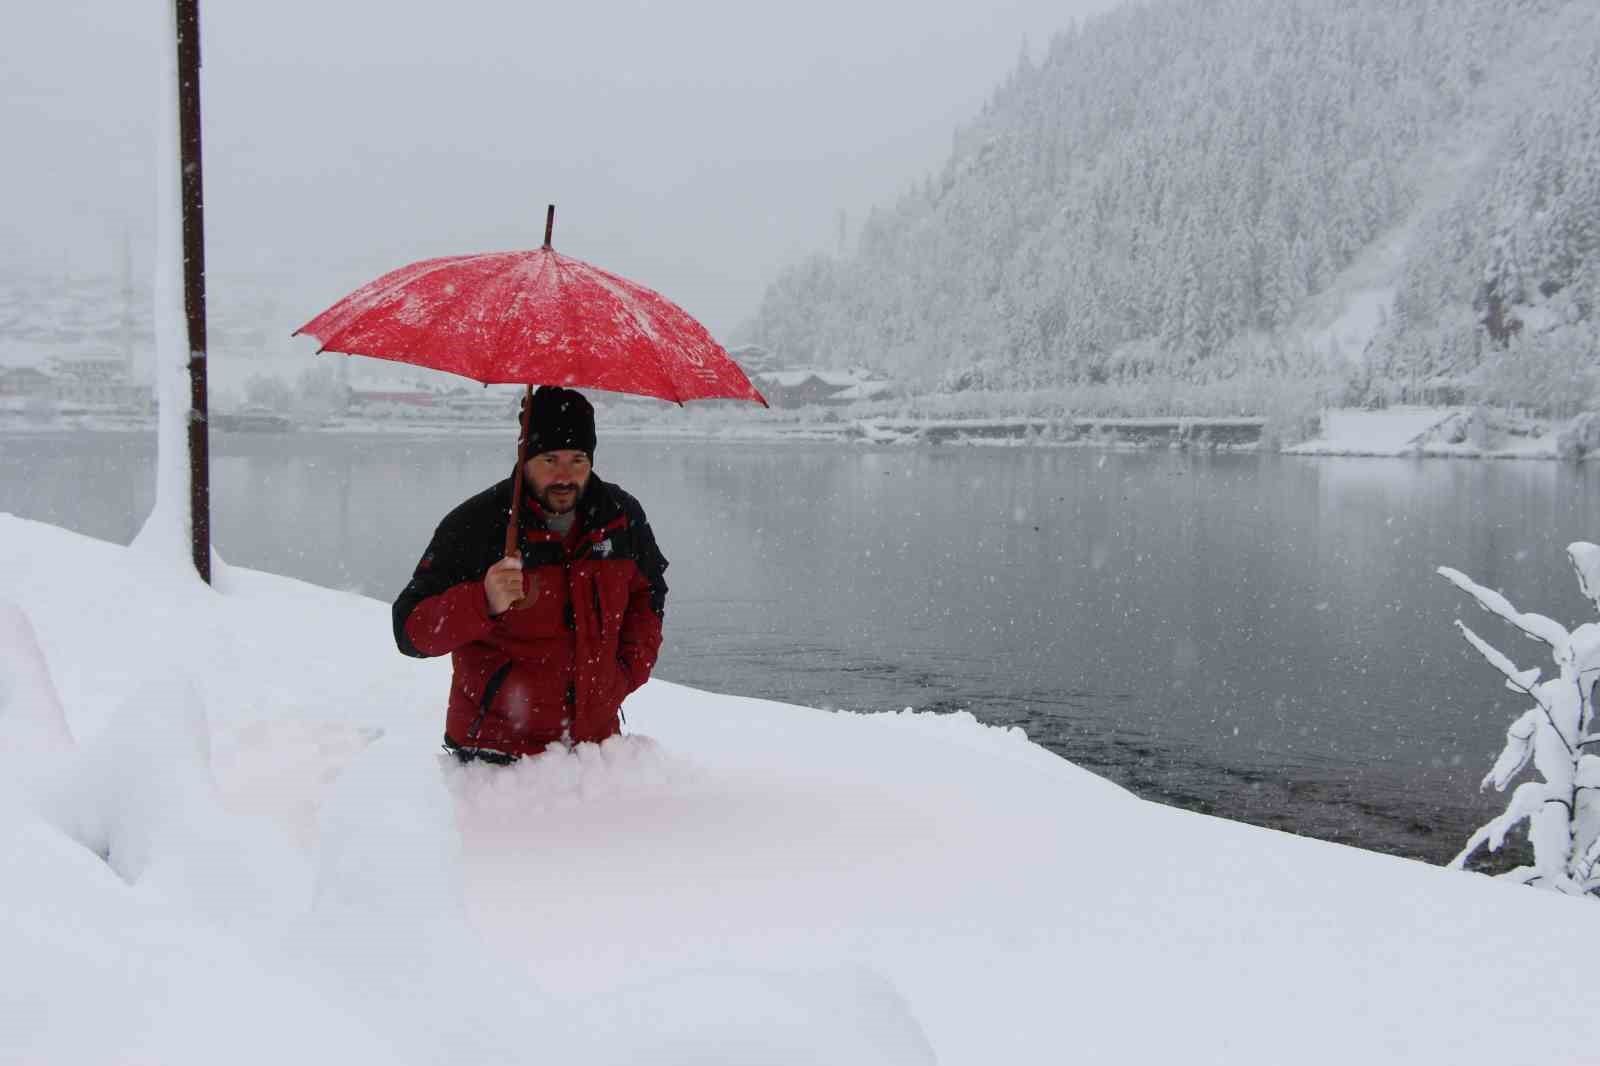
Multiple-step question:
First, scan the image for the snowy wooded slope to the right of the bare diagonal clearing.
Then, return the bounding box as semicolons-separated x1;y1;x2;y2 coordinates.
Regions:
1366;35;1600;415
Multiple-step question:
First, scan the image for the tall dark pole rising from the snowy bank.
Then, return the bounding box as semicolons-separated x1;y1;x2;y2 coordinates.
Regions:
173;0;211;583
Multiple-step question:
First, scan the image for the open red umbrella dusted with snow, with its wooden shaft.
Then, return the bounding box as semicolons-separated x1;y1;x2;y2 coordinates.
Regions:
294;205;766;555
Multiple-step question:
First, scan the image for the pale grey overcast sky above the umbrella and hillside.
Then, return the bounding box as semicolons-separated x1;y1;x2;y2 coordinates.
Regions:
0;0;1117;333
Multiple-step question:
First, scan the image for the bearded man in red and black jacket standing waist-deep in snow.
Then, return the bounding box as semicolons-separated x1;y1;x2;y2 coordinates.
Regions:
394;387;667;762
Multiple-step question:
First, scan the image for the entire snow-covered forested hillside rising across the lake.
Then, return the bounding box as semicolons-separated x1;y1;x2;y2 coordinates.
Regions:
742;0;1600;412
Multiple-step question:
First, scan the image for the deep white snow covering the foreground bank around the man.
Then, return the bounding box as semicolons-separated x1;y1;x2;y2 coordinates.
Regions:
0;515;1600;1066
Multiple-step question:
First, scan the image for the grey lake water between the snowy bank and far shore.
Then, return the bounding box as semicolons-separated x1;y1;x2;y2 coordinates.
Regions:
0;432;1600;861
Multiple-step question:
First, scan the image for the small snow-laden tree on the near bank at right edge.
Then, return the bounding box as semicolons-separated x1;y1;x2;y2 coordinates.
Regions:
1438;541;1600;895
